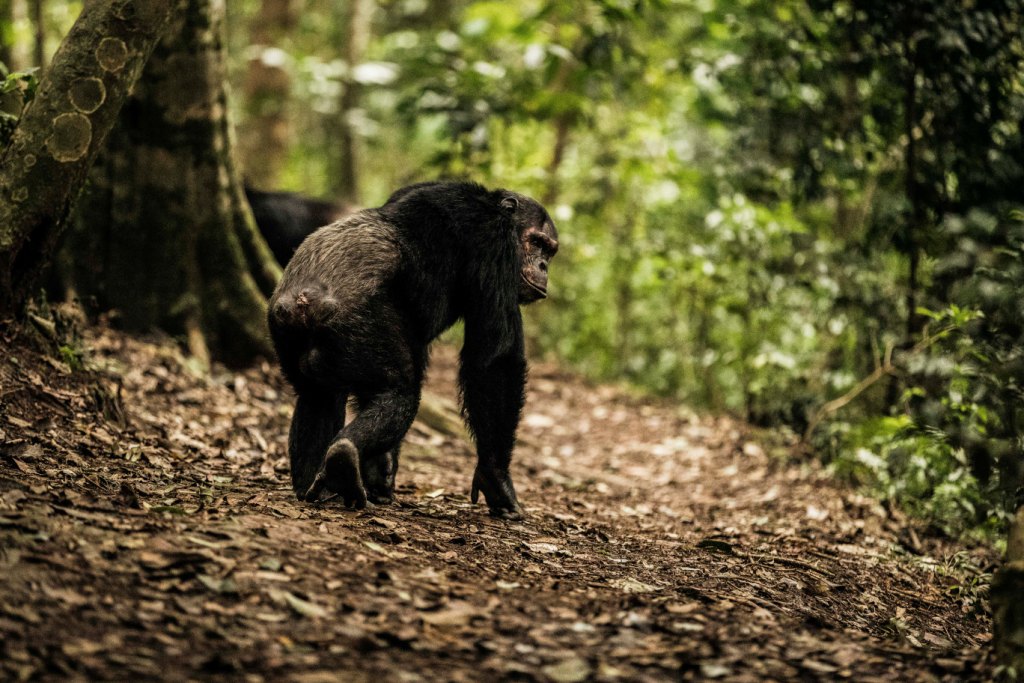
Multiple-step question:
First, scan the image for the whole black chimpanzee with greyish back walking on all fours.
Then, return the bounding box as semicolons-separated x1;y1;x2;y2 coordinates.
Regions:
268;182;558;518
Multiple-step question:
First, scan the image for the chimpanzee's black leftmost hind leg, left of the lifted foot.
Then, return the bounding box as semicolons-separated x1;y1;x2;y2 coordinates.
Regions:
288;389;348;498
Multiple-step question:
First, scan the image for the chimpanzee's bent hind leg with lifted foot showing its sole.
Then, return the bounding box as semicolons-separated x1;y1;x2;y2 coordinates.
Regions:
306;383;420;508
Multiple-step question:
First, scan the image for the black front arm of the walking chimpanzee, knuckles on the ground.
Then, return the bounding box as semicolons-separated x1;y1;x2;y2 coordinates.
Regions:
459;301;526;519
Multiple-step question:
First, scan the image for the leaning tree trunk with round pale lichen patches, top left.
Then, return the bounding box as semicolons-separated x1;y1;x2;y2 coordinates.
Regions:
0;0;174;318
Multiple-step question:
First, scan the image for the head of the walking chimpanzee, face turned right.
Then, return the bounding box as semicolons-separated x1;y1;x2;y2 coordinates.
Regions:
502;193;558;304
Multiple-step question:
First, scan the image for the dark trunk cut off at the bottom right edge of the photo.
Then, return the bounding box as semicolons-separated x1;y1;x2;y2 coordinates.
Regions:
991;507;1024;673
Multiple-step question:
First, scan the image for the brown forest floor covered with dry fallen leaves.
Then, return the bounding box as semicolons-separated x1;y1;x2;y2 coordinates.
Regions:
0;321;994;683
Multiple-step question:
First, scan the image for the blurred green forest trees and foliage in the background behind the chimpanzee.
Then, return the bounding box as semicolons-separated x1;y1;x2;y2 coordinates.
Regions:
0;0;1024;531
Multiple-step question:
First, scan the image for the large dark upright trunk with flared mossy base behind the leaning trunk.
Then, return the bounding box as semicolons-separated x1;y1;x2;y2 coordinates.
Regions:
66;0;281;365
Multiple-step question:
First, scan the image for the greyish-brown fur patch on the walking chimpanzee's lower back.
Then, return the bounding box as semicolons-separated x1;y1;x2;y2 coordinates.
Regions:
273;209;401;322
